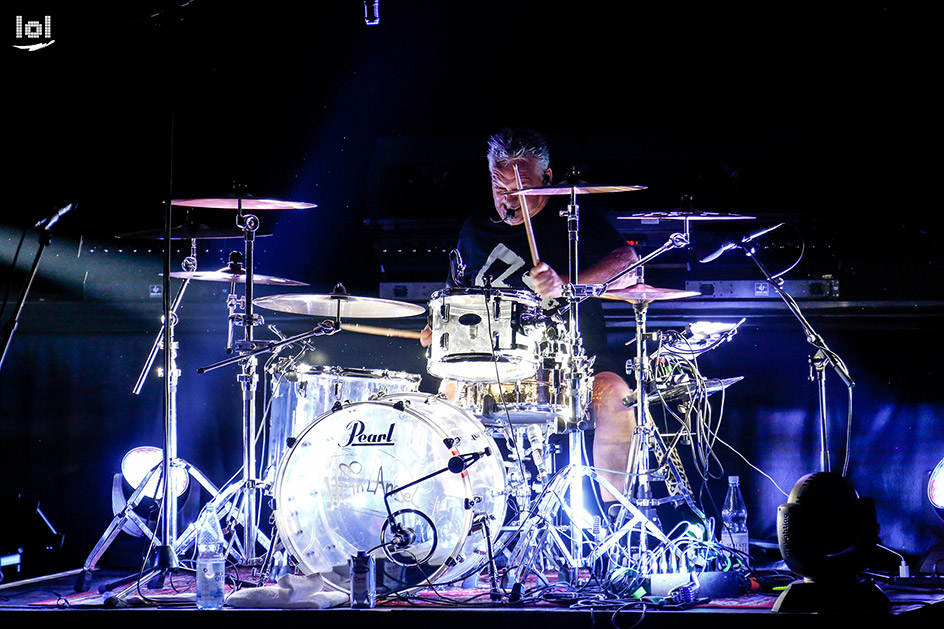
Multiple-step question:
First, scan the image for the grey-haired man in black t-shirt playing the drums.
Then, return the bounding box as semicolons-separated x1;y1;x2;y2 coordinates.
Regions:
420;129;638;510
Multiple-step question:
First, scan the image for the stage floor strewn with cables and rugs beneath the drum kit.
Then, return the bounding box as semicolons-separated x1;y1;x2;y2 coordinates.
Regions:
0;571;944;629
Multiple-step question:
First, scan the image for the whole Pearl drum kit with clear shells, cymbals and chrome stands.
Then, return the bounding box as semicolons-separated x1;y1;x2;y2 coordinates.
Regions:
77;184;764;602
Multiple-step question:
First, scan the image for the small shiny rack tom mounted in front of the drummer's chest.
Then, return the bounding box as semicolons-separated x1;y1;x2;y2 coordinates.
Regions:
426;288;545;382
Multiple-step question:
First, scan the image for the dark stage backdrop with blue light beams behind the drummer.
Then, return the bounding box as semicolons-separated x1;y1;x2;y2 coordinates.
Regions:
0;0;944;580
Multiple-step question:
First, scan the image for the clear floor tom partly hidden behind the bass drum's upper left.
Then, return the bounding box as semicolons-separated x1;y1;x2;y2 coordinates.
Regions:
268;365;421;467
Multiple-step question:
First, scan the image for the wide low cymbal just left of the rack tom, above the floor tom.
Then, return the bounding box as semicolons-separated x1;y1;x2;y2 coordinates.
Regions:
253;293;426;319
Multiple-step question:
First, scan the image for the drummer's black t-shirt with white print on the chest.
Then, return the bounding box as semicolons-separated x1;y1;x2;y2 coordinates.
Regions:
450;197;626;374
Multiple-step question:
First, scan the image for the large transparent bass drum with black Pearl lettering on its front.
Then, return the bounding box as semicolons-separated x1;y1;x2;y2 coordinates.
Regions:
275;393;507;595
